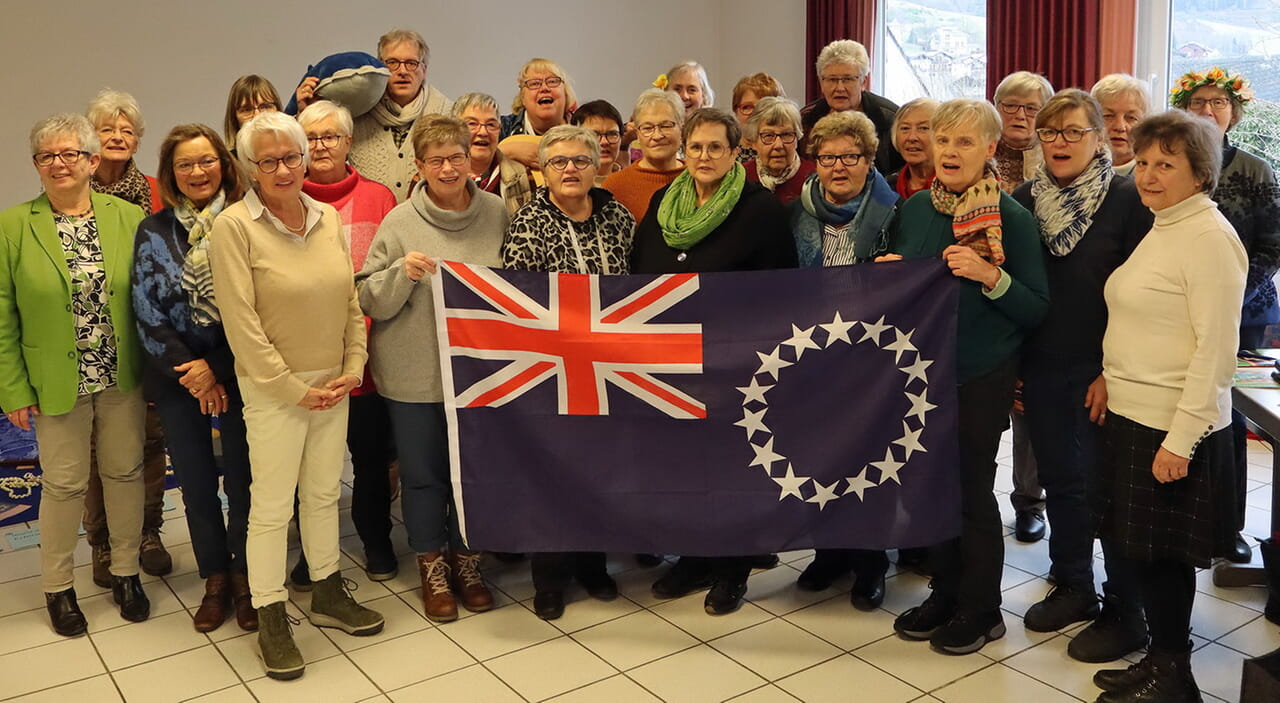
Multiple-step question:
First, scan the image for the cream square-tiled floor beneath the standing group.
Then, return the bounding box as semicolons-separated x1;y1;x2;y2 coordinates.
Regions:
0;438;1280;703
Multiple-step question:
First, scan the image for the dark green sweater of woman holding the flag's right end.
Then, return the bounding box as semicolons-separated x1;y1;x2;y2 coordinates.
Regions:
890;191;1048;383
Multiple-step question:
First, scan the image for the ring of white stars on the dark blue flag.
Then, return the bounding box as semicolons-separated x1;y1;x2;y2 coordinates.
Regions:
733;311;937;510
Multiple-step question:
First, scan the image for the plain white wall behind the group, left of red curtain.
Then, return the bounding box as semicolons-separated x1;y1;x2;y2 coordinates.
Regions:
0;0;805;207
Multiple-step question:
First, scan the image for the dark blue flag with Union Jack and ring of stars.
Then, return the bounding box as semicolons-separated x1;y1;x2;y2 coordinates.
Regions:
434;261;959;556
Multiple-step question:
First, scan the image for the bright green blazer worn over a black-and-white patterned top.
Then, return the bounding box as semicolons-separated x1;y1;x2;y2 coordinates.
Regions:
0;193;145;415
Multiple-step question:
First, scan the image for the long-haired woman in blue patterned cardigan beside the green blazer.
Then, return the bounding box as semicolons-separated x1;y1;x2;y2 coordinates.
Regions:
133;124;257;633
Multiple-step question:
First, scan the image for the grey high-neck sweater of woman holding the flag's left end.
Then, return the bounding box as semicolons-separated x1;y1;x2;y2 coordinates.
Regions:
356;179;507;403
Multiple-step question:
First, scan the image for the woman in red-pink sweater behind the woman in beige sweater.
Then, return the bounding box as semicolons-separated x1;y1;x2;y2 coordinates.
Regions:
298;100;397;581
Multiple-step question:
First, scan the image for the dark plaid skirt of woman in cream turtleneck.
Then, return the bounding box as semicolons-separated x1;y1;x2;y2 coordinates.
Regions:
1093;414;1236;567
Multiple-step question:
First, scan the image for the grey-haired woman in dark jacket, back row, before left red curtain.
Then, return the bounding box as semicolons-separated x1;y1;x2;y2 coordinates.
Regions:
800;40;902;173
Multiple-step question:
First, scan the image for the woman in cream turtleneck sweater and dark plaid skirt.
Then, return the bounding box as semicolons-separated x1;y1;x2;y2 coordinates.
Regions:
1093;110;1248;702
